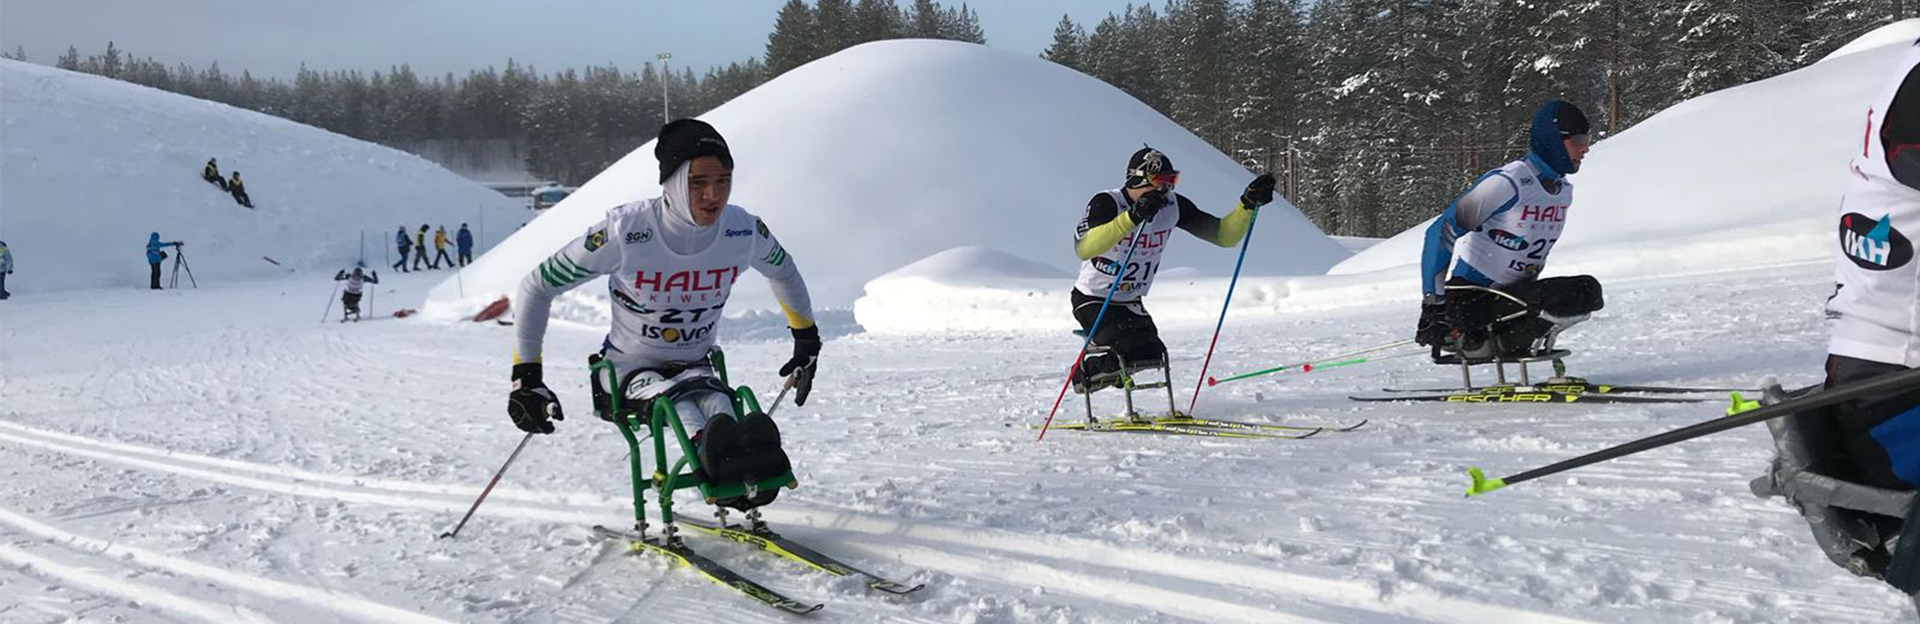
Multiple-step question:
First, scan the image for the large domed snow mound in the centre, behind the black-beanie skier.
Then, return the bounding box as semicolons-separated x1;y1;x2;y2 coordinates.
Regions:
428;40;1346;313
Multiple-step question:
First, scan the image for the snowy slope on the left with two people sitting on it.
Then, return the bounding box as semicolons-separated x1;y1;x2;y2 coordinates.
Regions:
0;60;526;294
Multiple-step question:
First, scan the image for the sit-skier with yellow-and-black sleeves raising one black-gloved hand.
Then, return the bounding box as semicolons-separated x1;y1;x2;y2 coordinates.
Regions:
1069;148;1273;394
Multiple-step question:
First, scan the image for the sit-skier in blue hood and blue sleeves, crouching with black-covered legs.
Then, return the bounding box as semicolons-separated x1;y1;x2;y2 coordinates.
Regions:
1413;100;1603;363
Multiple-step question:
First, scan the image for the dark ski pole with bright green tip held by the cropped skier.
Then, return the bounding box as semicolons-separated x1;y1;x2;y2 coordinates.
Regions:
1467;369;1920;495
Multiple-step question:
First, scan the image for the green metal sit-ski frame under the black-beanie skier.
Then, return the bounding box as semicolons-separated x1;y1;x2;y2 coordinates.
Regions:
589;348;801;545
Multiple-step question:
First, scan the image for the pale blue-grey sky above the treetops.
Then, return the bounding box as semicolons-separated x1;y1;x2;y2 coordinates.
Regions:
0;0;1158;77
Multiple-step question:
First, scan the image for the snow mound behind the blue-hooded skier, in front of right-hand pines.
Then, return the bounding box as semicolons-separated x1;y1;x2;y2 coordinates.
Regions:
1331;35;1920;282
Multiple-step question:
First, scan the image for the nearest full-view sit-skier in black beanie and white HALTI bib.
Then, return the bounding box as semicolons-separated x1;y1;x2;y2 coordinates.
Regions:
507;119;820;509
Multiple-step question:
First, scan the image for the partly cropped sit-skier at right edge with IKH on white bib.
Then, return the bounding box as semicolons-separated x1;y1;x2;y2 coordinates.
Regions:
1753;40;1920;603
